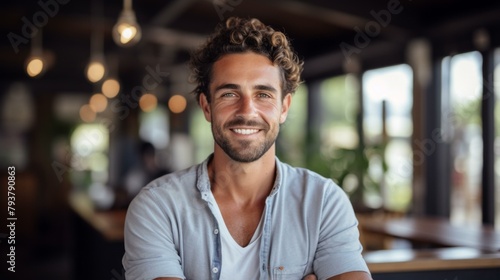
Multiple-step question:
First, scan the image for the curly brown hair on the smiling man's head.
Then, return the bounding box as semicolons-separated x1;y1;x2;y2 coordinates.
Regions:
190;17;303;102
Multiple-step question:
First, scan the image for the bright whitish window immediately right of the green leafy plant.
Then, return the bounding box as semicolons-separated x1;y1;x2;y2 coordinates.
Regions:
363;64;413;212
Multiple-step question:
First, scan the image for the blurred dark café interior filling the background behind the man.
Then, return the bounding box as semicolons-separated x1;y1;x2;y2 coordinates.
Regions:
0;0;500;280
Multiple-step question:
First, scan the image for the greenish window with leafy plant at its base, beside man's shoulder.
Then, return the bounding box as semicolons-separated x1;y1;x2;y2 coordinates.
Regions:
316;75;364;201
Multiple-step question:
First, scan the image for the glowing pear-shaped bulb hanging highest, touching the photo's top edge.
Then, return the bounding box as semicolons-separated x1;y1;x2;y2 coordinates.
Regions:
113;0;142;47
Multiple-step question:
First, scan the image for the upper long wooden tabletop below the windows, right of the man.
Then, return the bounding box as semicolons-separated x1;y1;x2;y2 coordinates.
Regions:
360;217;500;252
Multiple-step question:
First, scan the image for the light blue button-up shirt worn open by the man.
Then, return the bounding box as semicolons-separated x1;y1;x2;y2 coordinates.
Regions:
123;157;368;280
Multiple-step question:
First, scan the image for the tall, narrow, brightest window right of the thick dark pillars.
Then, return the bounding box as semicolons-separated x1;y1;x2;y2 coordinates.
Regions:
442;52;483;228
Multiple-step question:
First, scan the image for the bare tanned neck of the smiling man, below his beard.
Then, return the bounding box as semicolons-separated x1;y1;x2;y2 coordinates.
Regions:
208;149;276;206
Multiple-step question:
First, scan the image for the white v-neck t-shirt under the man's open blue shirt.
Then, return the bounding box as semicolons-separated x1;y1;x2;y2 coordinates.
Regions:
209;192;263;280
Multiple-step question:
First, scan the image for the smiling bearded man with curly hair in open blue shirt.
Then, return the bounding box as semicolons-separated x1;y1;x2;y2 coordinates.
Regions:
123;18;371;280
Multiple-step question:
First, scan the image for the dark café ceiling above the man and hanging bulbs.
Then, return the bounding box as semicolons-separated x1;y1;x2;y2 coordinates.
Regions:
0;0;500;95
